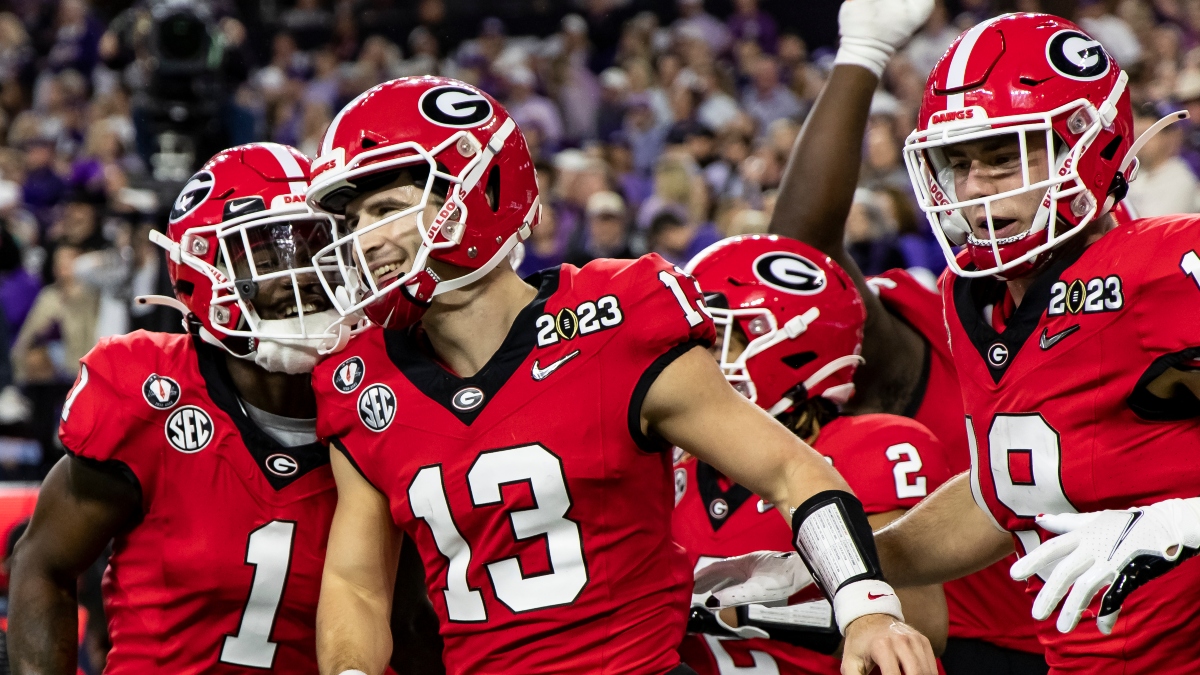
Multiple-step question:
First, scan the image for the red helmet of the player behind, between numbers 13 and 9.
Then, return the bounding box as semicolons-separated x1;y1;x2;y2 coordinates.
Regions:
686;234;866;416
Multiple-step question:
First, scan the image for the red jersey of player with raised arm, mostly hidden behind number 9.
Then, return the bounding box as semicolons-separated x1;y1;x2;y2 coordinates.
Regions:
869;269;1044;653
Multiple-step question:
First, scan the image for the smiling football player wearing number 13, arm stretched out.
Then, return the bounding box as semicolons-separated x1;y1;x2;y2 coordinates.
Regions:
308;77;936;675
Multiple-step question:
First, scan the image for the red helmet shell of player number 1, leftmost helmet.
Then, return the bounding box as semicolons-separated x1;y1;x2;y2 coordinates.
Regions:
167;143;311;354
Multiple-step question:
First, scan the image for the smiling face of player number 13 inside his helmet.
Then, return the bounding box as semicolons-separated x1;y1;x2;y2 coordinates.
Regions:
346;172;444;288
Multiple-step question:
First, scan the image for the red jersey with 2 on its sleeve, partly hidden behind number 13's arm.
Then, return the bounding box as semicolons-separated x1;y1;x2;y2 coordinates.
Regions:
673;414;952;675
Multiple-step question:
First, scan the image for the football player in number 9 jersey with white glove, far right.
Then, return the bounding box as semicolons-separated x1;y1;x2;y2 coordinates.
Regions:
700;14;1200;674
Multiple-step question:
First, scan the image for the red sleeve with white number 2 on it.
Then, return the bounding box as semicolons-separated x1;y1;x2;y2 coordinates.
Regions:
817;414;952;514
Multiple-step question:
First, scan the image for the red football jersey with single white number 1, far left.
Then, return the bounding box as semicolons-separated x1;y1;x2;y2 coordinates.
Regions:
59;330;337;675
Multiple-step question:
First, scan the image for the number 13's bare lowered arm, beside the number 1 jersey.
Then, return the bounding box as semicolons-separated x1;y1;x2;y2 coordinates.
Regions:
317;449;403;675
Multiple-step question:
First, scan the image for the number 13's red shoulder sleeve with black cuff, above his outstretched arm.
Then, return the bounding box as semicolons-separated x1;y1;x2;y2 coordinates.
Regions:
581;253;716;452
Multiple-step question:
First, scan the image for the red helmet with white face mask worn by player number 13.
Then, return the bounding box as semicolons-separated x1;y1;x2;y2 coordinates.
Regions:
308;77;540;328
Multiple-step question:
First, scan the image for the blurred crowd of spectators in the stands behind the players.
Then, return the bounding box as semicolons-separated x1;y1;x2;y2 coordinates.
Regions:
0;0;1200;478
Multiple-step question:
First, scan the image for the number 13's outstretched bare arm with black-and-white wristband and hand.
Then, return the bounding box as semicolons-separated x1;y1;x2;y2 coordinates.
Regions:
642;347;937;675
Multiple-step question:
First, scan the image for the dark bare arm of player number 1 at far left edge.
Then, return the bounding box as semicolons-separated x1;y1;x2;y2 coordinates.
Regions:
8;455;142;675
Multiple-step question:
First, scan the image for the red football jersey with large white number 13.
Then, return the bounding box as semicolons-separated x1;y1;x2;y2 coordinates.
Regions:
313;255;715;675
